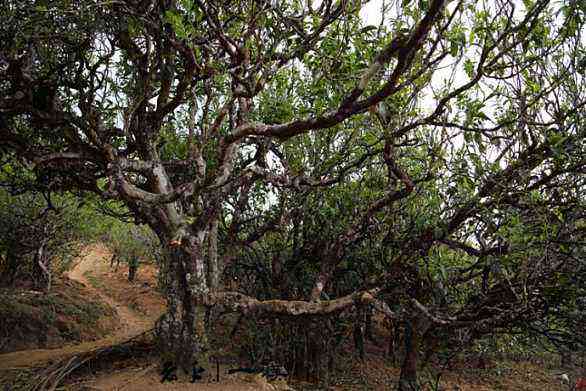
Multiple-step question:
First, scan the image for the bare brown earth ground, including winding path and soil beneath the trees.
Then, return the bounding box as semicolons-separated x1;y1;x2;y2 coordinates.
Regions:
0;245;584;391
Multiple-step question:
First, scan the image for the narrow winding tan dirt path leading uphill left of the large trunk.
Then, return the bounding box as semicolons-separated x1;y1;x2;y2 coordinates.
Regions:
0;245;152;370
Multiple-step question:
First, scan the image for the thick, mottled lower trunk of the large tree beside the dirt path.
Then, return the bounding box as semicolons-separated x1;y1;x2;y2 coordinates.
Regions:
155;239;208;372
